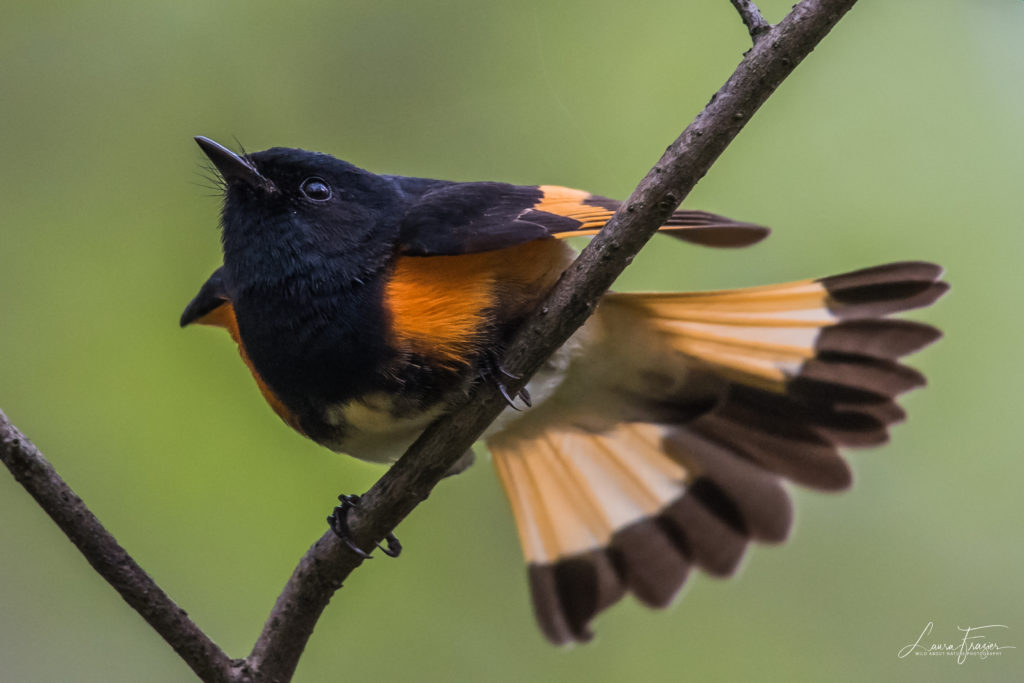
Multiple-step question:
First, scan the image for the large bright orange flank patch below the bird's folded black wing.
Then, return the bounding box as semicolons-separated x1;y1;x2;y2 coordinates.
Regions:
385;240;571;367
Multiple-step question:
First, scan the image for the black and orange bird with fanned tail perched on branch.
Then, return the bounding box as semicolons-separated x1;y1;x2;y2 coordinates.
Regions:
180;136;948;645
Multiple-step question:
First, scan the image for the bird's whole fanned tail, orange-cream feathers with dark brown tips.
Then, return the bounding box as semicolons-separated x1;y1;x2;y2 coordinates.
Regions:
488;262;948;643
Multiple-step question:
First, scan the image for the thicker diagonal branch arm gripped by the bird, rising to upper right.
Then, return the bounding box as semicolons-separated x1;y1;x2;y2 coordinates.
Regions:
250;0;856;680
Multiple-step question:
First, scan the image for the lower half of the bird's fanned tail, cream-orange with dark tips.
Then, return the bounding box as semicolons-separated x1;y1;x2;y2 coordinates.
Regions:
489;423;792;644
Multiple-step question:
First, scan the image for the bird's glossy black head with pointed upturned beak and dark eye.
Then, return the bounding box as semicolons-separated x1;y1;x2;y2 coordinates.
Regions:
196;136;402;284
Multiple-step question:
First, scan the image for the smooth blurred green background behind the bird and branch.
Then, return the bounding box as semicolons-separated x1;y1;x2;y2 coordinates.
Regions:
0;0;1024;682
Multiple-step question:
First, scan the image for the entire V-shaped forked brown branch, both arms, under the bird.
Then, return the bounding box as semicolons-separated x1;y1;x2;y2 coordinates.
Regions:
0;0;856;683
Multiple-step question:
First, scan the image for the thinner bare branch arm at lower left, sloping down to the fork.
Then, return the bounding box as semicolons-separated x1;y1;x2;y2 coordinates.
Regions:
0;411;234;681
